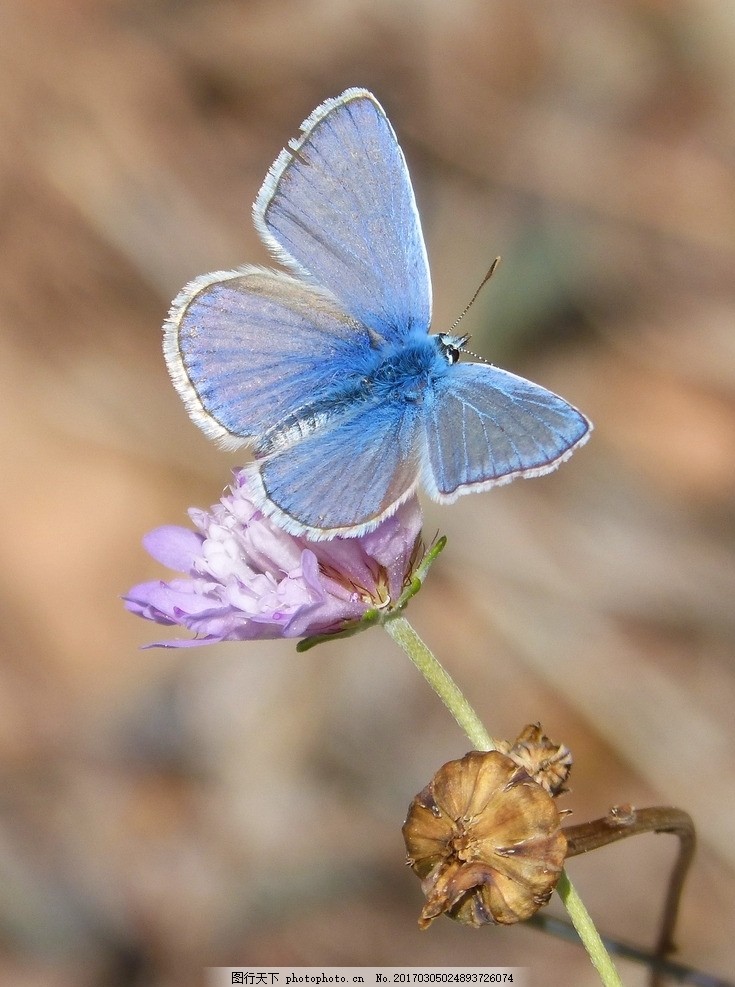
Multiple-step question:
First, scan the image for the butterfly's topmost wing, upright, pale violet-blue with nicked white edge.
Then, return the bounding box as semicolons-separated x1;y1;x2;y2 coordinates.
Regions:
253;89;431;342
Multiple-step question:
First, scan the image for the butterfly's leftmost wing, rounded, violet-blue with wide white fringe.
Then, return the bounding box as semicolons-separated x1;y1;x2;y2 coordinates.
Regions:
164;267;374;448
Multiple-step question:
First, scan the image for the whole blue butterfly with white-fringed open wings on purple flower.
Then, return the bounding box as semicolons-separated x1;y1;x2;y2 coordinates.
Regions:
164;89;592;539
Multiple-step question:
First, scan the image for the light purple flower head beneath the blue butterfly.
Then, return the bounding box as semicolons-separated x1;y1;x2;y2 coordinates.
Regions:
124;470;421;648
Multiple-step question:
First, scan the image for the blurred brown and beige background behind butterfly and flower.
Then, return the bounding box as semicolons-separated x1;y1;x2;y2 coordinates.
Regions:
0;0;735;987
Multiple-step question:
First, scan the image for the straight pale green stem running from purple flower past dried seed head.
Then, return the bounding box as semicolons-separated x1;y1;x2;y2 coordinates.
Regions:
383;617;622;987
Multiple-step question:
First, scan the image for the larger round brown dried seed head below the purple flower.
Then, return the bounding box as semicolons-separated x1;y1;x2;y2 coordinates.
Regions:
403;751;566;929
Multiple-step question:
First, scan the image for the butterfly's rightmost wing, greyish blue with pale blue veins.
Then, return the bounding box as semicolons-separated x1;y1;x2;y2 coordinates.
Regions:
422;363;592;503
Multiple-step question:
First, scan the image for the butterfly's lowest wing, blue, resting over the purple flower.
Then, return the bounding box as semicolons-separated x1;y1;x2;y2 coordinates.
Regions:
250;401;423;540
